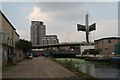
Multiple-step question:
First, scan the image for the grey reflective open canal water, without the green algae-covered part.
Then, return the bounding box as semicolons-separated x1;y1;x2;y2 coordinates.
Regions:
75;63;120;78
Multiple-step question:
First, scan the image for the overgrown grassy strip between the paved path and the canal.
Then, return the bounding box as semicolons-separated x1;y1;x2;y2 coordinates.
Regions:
49;57;98;80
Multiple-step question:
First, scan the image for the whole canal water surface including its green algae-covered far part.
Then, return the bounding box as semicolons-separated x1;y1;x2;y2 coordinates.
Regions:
56;58;120;79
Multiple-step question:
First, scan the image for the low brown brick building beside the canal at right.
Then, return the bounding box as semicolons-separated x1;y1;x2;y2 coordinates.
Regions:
94;37;120;55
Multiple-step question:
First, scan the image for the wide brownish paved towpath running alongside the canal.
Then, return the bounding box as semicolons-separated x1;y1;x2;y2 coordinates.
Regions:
3;57;74;78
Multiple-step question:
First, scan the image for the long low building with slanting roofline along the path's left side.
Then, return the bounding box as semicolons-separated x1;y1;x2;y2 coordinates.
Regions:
0;11;20;64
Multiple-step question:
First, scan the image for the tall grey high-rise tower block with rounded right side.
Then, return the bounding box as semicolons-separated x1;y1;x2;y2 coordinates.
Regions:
30;21;46;45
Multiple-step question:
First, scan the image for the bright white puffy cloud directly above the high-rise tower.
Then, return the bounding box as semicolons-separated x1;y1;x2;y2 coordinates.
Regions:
28;6;48;21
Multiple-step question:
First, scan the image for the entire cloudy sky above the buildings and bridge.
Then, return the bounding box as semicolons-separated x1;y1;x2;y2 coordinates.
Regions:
2;2;118;42
